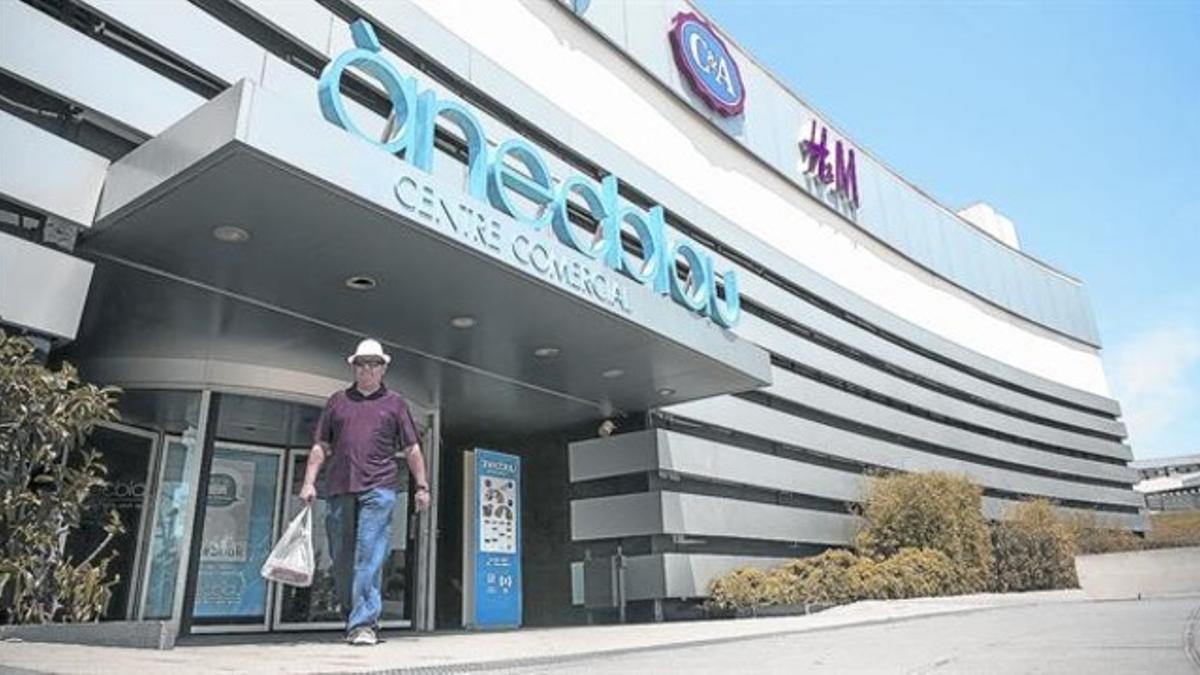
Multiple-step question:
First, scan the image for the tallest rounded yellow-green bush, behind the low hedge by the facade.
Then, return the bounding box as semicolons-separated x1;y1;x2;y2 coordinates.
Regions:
856;472;991;592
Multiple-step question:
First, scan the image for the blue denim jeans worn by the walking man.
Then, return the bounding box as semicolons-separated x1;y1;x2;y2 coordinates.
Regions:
325;488;396;632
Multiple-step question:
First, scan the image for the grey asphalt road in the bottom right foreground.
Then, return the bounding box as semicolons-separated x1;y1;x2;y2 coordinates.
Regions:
496;596;1200;675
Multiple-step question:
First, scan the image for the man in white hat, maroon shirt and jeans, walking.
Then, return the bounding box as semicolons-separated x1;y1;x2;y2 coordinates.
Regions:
300;339;430;645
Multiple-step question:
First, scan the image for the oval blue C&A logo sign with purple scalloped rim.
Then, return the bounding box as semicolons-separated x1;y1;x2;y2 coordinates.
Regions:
667;12;746;118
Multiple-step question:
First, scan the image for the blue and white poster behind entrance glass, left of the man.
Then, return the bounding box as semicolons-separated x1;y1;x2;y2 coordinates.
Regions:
193;447;280;617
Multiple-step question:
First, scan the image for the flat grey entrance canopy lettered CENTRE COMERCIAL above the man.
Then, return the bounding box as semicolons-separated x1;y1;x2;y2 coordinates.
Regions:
85;82;770;431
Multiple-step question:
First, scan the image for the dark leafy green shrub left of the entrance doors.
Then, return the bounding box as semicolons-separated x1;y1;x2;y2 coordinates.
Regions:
0;330;124;623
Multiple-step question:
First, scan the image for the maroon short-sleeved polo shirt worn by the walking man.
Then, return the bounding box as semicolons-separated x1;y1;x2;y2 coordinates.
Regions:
313;386;418;496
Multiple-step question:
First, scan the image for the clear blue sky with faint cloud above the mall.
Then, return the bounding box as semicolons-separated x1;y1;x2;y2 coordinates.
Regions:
696;0;1200;459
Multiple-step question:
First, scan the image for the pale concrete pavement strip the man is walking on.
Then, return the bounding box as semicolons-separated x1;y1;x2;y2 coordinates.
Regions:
0;591;1200;673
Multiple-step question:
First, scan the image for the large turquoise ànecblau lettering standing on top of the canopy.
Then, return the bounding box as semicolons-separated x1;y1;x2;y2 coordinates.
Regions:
317;19;742;328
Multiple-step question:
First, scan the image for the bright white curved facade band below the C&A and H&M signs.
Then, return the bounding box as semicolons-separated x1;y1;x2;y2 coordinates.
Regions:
405;0;1109;395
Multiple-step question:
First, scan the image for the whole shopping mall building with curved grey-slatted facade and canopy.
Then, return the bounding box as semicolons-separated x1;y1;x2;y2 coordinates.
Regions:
0;0;1145;633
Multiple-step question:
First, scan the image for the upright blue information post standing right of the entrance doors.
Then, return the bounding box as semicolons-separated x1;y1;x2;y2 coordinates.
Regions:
462;449;521;629
